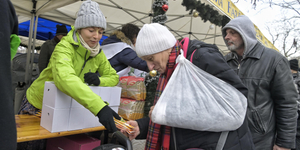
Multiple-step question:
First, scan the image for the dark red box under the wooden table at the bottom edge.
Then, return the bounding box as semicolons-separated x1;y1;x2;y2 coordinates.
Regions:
46;134;101;150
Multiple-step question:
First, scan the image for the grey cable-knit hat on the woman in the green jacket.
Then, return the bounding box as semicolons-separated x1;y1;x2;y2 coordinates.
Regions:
74;0;106;30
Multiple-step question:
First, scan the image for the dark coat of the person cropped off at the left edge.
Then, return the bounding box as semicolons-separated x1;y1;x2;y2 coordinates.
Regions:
0;0;18;150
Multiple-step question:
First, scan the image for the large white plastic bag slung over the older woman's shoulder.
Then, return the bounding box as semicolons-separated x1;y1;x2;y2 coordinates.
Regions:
151;55;247;132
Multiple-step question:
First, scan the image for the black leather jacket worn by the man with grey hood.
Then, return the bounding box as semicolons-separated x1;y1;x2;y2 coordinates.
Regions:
225;43;297;149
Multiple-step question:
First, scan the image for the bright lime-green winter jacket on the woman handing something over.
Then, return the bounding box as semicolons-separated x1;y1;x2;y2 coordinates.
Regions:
26;27;119;115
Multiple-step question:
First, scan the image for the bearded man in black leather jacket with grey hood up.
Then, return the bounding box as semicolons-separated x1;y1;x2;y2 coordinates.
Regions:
222;16;297;150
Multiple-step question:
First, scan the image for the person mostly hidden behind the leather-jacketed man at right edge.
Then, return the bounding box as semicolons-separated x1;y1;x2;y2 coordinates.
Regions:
289;59;300;150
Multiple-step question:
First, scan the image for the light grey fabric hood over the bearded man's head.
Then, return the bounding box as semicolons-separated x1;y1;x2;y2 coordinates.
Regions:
222;15;258;57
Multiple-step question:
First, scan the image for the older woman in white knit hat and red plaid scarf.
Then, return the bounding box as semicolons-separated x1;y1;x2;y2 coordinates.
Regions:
122;23;254;150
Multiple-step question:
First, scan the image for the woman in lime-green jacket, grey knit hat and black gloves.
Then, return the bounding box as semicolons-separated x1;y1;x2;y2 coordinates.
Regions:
20;0;120;135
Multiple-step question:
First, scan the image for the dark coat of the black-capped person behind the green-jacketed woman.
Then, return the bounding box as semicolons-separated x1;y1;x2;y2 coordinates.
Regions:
39;38;58;73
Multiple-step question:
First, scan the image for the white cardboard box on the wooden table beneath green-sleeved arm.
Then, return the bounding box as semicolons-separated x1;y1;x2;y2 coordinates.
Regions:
41;82;121;132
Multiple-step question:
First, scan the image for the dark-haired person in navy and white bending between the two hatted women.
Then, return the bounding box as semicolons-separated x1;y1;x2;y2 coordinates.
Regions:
101;23;149;77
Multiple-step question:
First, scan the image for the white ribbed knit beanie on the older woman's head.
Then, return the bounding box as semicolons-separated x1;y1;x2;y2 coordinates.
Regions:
135;23;176;57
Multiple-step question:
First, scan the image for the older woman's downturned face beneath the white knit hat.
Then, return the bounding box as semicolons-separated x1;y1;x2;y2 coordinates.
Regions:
143;48;172;74
